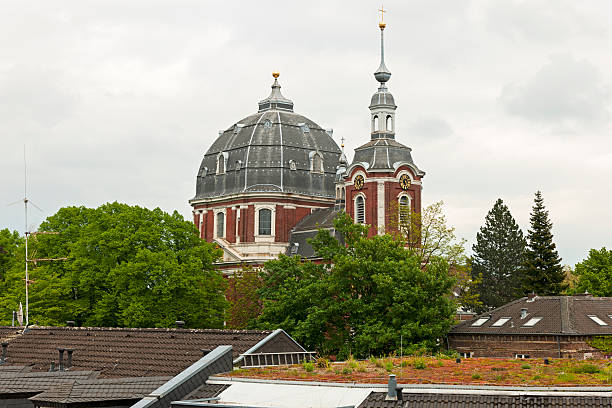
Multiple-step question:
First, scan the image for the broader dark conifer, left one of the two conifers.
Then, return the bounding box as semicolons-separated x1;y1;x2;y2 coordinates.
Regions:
472;199;527;312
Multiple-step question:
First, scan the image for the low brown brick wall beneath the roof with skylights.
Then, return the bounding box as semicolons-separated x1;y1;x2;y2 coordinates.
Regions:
448;334;606;359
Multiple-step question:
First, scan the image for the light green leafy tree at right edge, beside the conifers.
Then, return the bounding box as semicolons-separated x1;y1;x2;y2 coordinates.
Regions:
574;248;612;296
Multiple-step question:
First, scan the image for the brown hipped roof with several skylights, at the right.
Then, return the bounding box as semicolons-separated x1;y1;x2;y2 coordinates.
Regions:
450;295;612;335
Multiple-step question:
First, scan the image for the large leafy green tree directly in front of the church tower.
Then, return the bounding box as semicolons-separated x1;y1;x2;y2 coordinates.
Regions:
251;213;456;358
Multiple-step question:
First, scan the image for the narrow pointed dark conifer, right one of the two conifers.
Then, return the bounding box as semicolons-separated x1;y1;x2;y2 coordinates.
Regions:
522;191;566;296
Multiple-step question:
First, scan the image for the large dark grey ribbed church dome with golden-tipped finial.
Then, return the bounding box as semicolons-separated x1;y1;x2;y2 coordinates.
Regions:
191;73;341;201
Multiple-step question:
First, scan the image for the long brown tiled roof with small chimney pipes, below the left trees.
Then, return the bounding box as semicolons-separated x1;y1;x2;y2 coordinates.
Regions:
0;327;272;378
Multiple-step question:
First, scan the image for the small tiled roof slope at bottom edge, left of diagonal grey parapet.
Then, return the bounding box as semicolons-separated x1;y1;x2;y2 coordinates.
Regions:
30;377;171;405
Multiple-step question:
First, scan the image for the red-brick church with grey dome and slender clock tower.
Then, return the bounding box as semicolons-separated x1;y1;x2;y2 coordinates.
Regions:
189;21;425;273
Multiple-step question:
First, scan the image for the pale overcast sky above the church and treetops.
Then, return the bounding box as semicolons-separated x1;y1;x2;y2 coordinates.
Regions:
0;0;612;265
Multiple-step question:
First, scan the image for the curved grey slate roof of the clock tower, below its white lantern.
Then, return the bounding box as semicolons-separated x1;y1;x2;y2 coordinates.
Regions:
349;138;425;176
